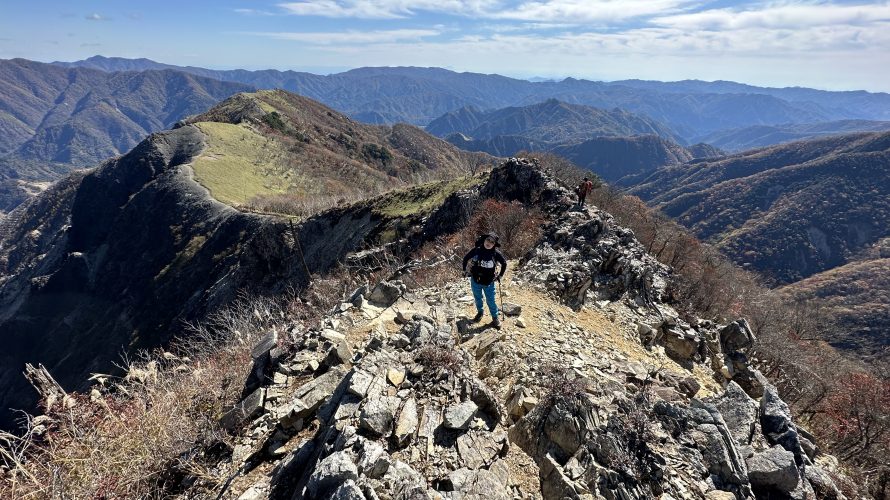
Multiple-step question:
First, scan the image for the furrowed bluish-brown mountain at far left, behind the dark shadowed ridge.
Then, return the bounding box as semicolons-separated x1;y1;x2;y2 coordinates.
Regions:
0;59;252;212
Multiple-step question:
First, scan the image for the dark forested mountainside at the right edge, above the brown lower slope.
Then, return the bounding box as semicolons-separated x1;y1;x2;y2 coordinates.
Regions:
631;132;890;283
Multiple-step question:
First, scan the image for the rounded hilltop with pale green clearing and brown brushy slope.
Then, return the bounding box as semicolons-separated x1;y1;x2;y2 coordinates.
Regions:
190;91;495;214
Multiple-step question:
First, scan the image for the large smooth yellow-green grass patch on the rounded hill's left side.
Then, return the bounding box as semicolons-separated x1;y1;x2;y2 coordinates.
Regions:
192;122;290;206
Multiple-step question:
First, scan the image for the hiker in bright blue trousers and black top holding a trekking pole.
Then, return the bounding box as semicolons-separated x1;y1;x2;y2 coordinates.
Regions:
463;233;507;328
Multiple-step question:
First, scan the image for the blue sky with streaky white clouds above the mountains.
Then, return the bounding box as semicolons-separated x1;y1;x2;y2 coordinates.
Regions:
0;0;890;91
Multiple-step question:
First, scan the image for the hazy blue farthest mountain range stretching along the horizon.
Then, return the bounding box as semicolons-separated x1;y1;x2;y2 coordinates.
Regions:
54;56;890;140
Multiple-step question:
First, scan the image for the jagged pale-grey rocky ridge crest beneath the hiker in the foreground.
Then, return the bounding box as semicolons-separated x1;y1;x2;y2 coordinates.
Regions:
170;159;845;500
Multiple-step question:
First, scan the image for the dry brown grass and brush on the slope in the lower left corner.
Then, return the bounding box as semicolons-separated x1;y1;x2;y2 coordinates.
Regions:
0;299;292;499
